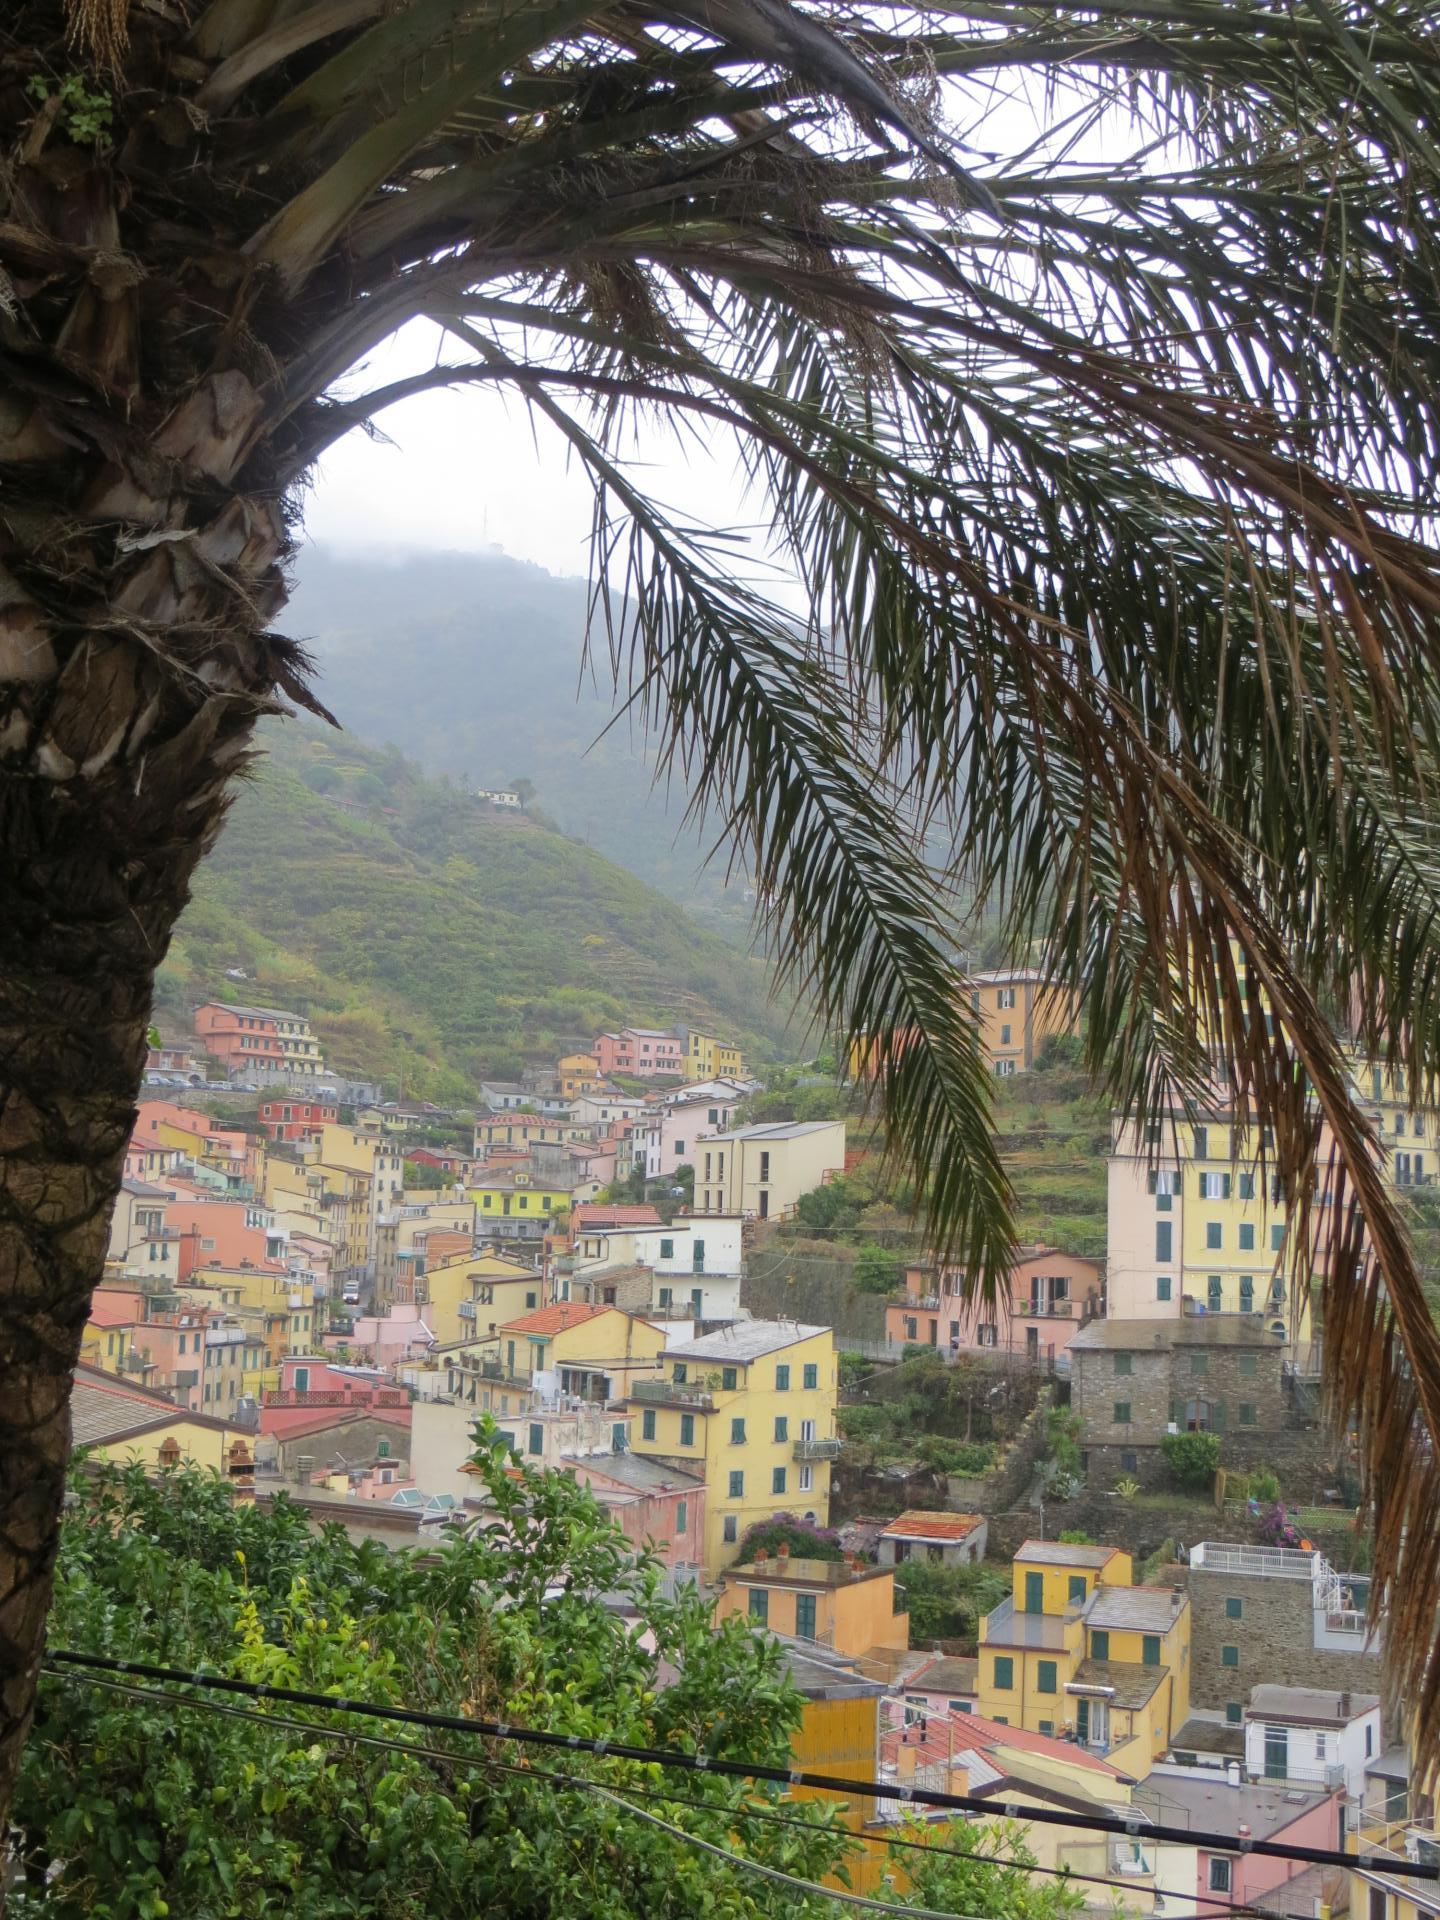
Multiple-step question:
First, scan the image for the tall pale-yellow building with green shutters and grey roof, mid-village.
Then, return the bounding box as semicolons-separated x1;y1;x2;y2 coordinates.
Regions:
632;1321;841;1578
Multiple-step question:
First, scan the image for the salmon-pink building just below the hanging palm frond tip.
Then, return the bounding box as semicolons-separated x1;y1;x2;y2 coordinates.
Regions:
885;1246;1100;1365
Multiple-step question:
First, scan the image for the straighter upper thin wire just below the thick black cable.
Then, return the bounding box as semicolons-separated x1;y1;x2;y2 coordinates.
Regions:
46;1670;1265;1920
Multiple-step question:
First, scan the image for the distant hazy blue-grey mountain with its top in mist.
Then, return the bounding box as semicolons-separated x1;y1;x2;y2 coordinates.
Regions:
284;545;749;925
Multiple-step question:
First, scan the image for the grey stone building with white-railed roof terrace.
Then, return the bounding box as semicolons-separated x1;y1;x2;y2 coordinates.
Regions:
1188;1540;1380;1728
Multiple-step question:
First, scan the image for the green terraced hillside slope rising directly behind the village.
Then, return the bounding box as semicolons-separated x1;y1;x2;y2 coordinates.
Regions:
157;722;806;1098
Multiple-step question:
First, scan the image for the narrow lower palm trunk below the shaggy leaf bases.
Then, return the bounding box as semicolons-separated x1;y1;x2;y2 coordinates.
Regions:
0;748;242;1816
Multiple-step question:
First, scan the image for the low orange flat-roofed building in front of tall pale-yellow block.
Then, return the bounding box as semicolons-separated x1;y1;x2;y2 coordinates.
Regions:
714;1553;910;1655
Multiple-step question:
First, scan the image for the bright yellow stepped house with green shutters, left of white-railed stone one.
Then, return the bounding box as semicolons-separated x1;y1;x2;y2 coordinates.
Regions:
977;1540;1190;1780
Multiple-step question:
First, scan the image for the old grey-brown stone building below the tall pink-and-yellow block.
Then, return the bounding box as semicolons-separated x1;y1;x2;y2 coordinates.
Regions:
1069;1313;1290;1484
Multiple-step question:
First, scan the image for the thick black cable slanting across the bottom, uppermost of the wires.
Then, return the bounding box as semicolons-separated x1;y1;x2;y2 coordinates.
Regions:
44;1649;1440;1882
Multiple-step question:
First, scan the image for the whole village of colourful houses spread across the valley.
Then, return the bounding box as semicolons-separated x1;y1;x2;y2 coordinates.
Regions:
75;970;1440;1920
